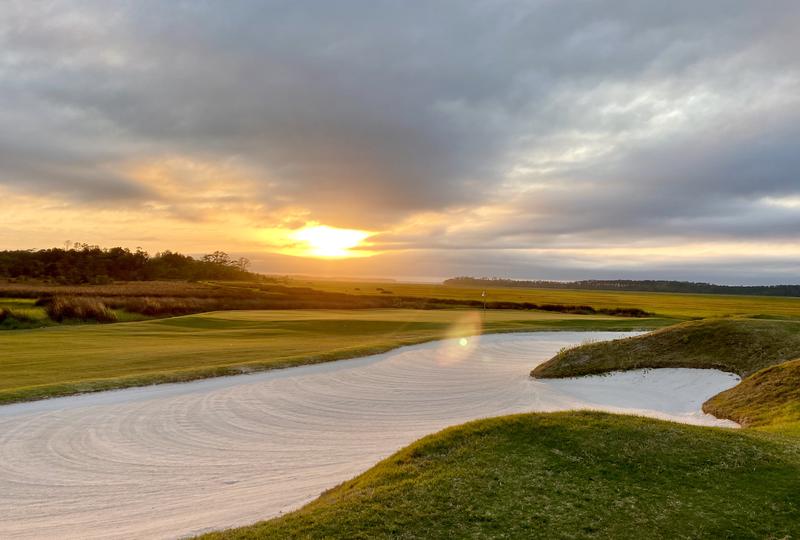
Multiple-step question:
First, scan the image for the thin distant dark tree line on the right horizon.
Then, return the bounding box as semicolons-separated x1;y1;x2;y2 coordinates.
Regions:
444;276;800;296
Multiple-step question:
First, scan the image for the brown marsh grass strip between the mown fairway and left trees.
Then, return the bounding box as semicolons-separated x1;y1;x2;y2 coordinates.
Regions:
0;281;664;329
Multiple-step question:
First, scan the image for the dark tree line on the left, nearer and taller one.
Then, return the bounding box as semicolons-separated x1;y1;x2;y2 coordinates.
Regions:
0;244;254;285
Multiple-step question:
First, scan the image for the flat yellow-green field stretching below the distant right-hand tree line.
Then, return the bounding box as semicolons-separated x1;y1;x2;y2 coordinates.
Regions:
288;279;800;319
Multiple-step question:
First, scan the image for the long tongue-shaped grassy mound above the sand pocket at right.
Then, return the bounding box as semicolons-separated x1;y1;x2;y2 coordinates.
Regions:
531;318;800;378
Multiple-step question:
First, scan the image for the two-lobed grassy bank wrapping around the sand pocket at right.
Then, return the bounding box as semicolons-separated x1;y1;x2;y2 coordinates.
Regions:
531;319;800;431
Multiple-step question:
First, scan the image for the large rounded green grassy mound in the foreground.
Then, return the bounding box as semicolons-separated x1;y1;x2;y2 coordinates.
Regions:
206;412;800;539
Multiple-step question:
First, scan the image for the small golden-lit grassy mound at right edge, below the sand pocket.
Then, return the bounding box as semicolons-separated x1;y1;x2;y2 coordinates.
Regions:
703;359;800;427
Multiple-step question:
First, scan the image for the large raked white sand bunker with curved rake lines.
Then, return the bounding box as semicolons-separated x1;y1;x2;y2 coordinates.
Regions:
0;332;739;539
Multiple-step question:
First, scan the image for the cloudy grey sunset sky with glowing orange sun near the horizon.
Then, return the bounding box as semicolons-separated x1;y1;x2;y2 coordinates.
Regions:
0;0;800;284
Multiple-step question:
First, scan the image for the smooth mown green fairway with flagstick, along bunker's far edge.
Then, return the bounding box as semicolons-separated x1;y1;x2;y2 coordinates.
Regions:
0;310;671;403
